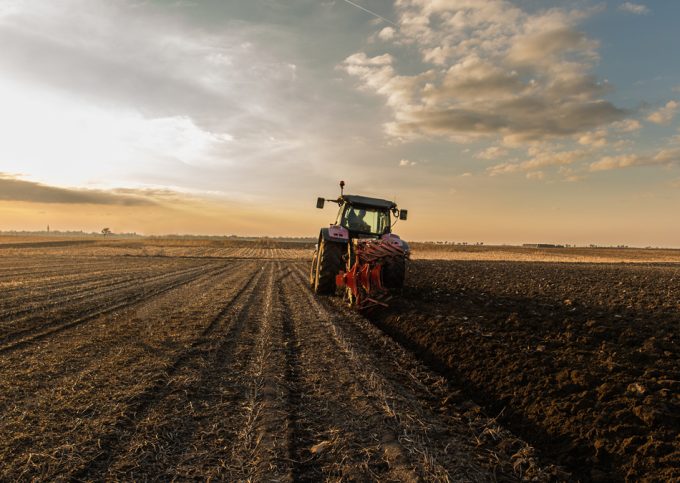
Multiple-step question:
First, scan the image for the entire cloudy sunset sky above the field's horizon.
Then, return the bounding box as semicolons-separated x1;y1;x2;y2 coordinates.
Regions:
0;0;680;247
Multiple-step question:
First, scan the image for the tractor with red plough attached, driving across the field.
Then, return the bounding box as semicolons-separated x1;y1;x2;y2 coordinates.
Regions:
309;181;409;311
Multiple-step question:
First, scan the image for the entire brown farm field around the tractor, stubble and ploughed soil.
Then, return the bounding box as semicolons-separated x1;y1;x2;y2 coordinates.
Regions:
0;239;680;481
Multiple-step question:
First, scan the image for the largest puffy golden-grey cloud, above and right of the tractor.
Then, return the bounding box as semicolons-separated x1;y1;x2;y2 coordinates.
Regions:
342;0;626;144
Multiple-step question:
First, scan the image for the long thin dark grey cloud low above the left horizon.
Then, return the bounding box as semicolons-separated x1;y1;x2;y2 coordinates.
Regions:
0;173;155;206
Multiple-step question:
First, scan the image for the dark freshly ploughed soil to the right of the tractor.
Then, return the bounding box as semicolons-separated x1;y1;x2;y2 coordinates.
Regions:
374;261;680;481
